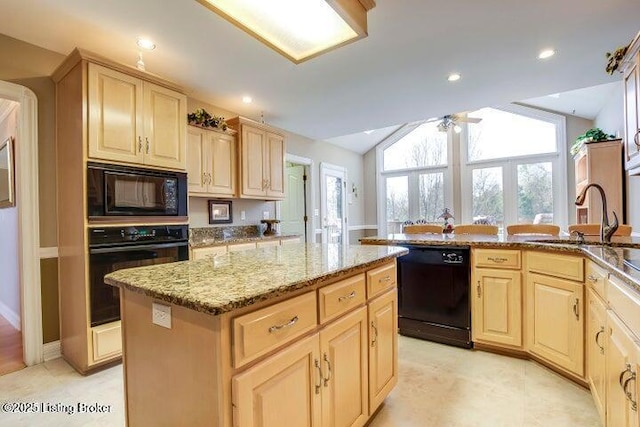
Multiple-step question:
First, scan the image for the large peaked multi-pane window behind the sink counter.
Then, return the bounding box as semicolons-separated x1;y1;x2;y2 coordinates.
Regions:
377;105;568;234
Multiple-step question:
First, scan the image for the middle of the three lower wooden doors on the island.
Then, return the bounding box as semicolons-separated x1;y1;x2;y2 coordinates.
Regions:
320;307;369;427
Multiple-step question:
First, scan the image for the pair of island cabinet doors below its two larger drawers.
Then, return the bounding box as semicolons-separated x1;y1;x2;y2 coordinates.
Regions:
232;307;369;427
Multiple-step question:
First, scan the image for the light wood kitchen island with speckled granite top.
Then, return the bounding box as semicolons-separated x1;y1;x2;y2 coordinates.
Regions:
105;244;406;426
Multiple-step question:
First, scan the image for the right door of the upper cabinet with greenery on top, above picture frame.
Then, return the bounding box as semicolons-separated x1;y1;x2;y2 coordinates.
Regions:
209;132;236;196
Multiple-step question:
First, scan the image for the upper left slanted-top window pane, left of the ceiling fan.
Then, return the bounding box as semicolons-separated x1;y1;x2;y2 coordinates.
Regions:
383;123;447;171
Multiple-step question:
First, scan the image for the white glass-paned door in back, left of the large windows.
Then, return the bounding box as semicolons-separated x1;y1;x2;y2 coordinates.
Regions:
320;163;349;245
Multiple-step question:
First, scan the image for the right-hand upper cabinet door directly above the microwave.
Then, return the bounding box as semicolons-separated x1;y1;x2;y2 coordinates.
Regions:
144;82;187;170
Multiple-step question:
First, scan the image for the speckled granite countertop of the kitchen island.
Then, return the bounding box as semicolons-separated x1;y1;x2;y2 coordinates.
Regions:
104;242;407;315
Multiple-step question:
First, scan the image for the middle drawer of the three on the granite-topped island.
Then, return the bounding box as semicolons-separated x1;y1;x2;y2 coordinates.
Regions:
318;273;367;323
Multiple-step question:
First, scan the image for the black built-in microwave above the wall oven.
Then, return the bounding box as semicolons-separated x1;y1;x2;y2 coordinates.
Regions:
87;163;188;220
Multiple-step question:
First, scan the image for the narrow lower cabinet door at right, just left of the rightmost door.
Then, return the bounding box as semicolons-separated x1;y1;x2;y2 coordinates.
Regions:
586;290;607;425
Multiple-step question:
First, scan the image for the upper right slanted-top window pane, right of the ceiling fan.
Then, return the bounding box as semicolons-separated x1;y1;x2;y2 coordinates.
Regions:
467;108;558;162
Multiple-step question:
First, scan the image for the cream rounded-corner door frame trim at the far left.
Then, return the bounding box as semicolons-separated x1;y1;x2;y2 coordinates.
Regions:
0;81;44;366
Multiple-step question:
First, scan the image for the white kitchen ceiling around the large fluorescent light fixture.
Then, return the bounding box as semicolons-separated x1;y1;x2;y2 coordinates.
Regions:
0;0;640;151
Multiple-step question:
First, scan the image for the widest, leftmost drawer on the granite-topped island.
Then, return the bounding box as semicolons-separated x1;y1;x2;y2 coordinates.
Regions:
233;292;318;368
